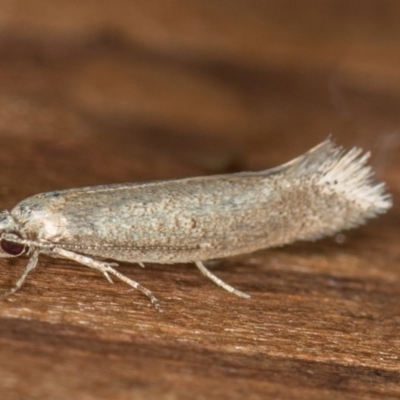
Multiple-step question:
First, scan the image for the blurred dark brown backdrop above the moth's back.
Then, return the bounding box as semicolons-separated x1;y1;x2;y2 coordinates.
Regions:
0;0;400;206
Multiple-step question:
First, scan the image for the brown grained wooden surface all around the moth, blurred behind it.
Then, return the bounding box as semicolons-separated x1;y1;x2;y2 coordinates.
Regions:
0;0;400;400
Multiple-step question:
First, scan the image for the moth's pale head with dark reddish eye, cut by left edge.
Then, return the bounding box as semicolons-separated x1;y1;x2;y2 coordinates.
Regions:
0;211;28;258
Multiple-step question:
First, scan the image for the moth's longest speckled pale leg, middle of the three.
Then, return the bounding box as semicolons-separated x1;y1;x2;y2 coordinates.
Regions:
46;247;162;312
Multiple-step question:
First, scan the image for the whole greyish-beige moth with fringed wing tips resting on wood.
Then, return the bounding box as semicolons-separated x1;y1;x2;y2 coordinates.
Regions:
0;139;392;311
